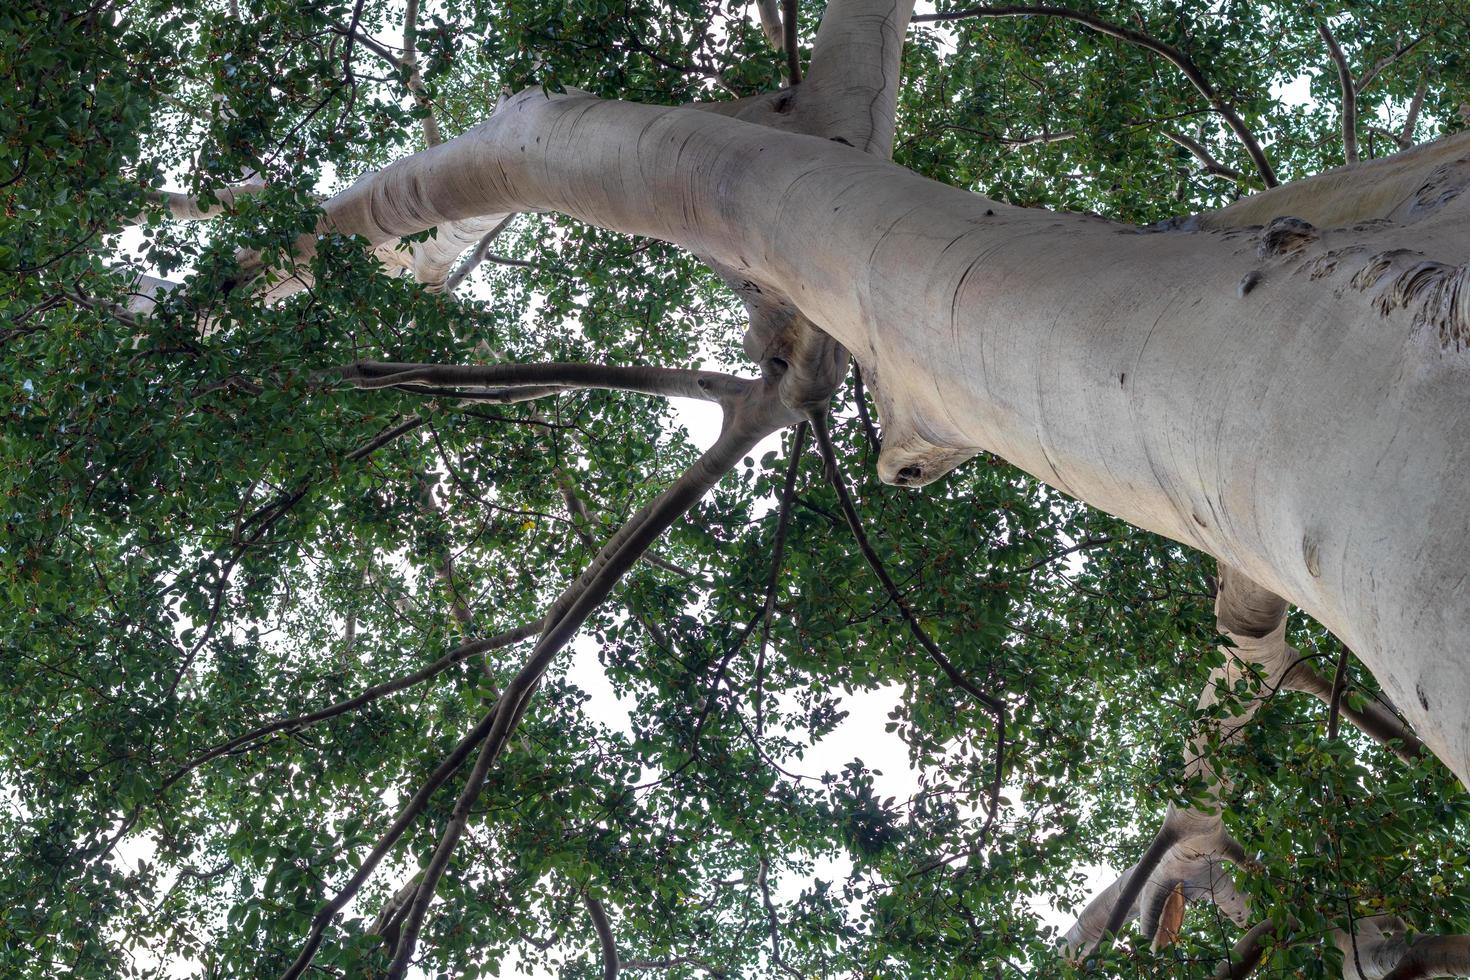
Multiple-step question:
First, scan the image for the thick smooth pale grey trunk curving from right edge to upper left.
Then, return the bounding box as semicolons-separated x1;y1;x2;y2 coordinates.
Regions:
310;88;1470;779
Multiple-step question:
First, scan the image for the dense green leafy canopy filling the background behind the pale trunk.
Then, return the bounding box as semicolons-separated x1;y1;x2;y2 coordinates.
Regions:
0;0;1470;979
